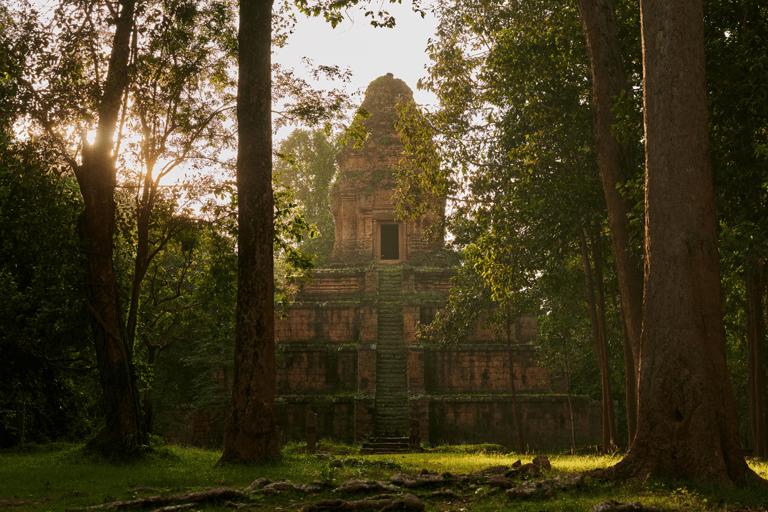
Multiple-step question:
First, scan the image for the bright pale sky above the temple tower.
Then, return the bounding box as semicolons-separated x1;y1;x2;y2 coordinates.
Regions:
273;0;437;139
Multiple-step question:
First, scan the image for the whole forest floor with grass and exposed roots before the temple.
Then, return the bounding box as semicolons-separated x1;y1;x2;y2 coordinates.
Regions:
0;441;768;512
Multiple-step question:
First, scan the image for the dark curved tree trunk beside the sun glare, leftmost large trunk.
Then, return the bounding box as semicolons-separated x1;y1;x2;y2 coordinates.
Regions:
75;0;148;453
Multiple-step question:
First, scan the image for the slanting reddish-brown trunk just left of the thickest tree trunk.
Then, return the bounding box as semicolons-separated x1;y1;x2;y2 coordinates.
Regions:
578;0;643;444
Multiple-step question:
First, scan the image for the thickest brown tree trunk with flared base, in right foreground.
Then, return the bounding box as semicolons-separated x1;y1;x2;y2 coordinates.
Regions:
605;0;760;485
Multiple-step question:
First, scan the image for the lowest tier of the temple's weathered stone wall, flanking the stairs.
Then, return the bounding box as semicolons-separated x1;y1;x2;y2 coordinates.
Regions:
276;395;602;450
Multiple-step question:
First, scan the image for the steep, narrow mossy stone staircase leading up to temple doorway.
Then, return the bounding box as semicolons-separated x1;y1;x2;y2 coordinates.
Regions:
374;268;409;440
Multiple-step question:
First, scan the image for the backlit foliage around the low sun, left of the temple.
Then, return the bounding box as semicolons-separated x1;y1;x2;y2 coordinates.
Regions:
0;0;356;448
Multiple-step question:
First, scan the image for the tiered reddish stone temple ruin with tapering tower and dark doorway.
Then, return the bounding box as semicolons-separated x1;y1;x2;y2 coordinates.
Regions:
275;74;601;448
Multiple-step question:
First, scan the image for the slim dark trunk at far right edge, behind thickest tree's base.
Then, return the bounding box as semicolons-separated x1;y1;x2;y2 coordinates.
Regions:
746;265;768;457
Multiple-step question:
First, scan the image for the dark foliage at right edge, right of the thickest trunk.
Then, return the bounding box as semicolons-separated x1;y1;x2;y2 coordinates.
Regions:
704;0;768;446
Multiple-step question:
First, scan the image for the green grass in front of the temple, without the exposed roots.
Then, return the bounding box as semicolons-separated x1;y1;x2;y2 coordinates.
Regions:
0;442;768;512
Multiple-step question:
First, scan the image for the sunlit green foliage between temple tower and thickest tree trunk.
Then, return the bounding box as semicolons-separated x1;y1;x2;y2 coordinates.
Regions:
397;1;637;426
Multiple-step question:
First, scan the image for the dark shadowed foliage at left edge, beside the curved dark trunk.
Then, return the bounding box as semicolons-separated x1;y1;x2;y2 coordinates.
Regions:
0;140;99;447
